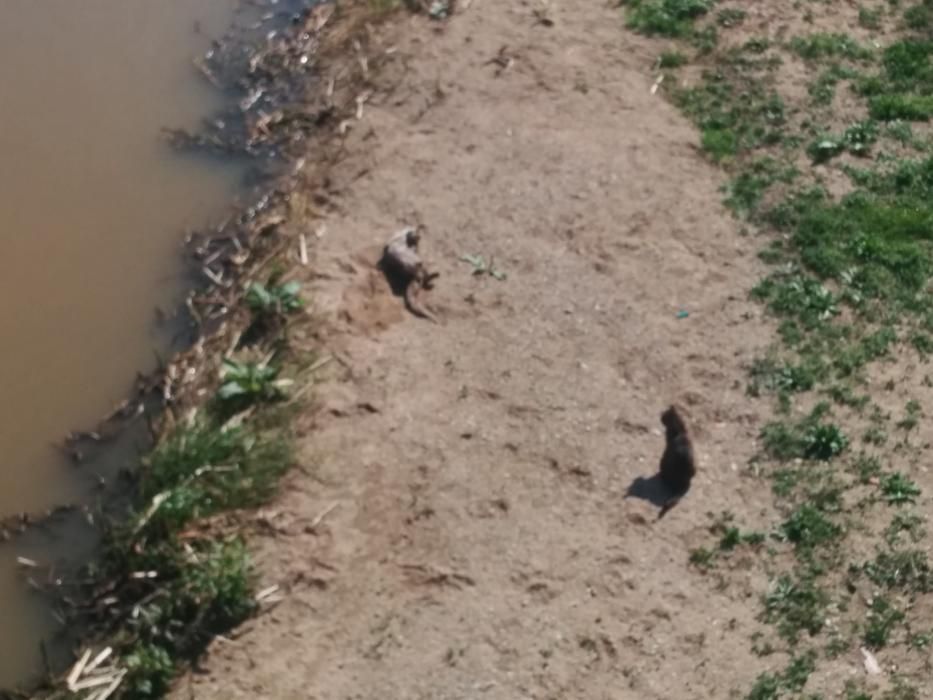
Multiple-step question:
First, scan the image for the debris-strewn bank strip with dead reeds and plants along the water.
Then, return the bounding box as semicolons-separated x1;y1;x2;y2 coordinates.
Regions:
7;1;402;698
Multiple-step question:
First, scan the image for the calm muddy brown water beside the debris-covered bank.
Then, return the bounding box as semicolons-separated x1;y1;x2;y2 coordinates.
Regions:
0;0;253;687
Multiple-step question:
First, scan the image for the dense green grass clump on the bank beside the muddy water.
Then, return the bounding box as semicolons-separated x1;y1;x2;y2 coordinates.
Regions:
89;410;291;698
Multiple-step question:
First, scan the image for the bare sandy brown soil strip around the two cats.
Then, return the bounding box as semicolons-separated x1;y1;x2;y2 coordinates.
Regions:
169;0;786;700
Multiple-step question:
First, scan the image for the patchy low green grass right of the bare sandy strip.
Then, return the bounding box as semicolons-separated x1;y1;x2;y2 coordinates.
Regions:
628;0;933;700
